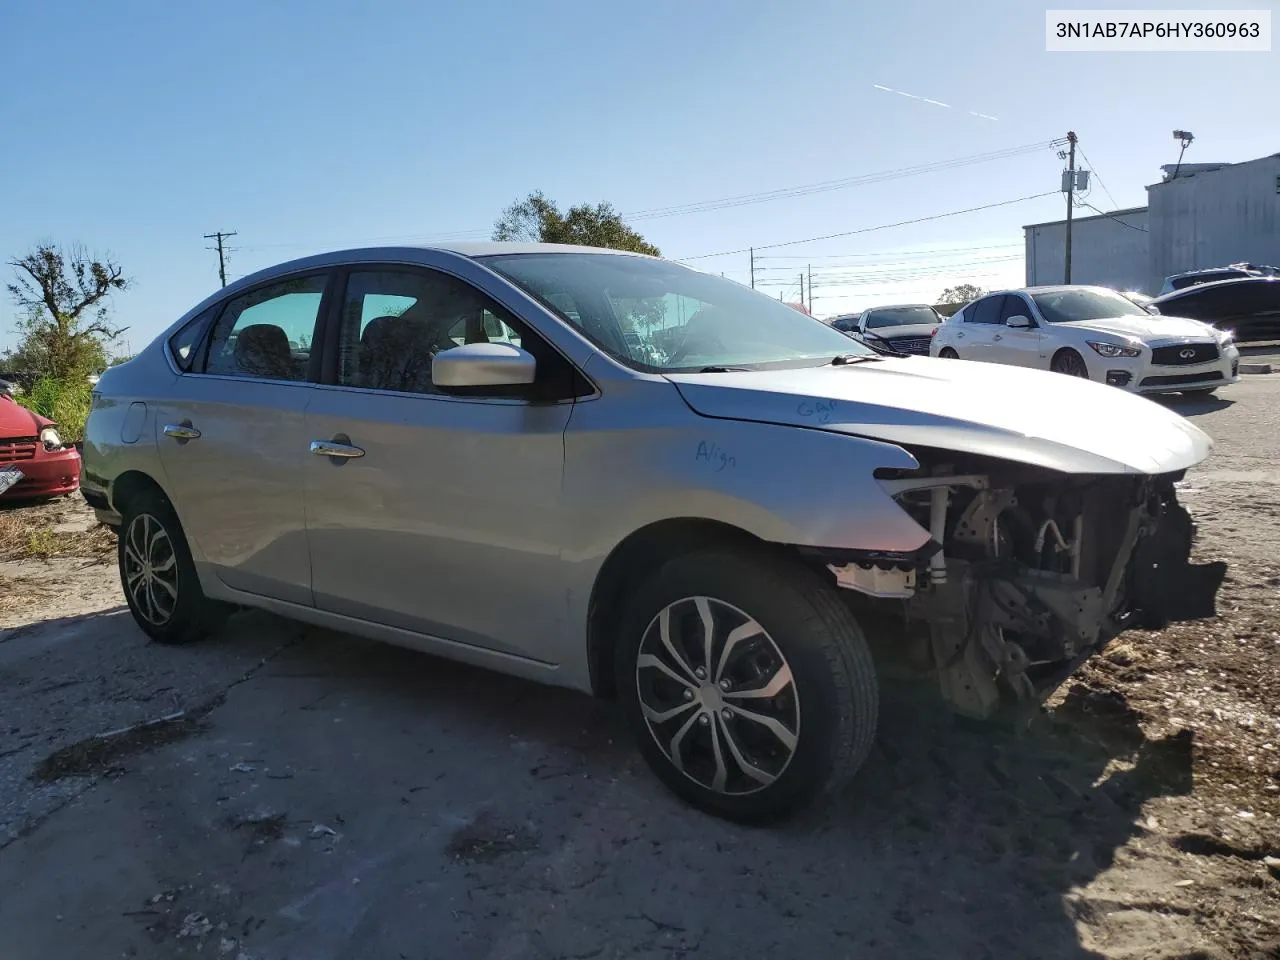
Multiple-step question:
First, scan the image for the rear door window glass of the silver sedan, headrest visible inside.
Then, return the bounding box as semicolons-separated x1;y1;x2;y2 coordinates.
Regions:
205;275;325;380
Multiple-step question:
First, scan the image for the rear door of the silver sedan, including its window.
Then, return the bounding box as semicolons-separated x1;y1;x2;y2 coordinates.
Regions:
156;273;328;604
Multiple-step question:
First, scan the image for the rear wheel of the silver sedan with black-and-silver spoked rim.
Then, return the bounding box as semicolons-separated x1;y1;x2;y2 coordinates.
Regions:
116;490;230;644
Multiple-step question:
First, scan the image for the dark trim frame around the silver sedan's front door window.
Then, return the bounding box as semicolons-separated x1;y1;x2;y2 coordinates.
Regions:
320;260;600;407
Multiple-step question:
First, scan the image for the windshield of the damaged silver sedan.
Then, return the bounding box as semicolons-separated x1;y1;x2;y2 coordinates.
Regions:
484;253;876;372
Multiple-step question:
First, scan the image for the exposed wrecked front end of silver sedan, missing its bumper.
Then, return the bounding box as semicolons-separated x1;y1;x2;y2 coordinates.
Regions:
826;454;1226;717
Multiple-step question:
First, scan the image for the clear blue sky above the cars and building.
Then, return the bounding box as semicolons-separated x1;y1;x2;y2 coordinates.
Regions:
0;0;1280;349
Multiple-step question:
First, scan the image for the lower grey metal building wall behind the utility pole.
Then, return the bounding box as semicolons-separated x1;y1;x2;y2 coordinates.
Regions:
1025;210;1151;291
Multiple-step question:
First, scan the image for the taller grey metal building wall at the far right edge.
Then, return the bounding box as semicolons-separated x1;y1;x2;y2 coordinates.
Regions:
1152;155;1280;292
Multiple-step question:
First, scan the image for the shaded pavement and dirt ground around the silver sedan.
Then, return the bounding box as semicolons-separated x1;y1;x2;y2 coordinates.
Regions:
0;375;1280;960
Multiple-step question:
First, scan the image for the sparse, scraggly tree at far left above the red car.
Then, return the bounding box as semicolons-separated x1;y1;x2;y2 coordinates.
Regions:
8;243;129;380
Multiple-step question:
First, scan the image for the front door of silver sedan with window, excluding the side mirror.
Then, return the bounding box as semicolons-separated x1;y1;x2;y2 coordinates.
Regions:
303;266;573;660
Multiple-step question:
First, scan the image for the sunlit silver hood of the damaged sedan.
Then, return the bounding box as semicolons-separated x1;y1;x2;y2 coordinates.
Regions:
668;357;1212;474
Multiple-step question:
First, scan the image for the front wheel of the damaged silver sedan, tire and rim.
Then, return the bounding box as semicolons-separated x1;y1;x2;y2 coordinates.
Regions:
616;548;879;823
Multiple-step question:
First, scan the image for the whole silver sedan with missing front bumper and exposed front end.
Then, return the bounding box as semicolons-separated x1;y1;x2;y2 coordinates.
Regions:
82;244;1224;820
